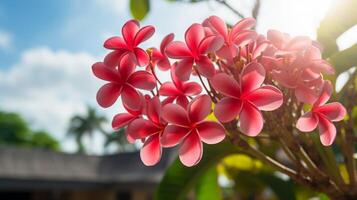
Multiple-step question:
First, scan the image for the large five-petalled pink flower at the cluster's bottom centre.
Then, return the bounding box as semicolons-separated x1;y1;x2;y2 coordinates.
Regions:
161;95;225;167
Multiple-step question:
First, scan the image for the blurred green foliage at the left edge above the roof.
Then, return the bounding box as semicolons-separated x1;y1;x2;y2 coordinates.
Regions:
0;112;60;151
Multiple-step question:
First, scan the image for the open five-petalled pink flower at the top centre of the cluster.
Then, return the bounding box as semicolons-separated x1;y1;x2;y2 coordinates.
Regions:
166;23;223;81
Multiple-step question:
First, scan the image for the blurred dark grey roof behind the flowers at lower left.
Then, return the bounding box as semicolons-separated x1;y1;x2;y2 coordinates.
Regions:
0;146;174;188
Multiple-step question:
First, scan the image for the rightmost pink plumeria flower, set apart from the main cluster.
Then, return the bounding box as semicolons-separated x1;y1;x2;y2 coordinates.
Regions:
296;81;346;146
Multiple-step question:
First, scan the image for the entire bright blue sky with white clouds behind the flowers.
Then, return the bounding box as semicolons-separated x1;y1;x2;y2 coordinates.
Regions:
0;0;356;153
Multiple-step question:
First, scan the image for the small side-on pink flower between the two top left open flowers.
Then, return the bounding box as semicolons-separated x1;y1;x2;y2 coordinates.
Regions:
151;33;175;71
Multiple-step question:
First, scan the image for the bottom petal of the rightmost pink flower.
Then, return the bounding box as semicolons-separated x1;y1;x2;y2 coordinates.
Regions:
319;117;336;146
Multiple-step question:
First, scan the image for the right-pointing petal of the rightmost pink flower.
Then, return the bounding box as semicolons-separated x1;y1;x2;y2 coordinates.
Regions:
314;102;346;122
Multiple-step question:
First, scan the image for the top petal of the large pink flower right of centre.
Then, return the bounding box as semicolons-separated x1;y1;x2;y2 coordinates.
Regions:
241;62;265;94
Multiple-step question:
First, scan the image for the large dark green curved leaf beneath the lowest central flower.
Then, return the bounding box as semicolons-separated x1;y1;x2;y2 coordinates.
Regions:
155;142;240;200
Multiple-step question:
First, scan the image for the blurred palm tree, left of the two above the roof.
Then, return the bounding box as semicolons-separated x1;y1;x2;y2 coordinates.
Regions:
68;106;107;153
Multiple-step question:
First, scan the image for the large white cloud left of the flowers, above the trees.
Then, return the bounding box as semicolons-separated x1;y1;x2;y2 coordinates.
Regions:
0;47;108;152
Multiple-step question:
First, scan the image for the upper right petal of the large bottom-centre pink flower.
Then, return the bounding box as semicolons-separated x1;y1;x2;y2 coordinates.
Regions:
188;94;212;123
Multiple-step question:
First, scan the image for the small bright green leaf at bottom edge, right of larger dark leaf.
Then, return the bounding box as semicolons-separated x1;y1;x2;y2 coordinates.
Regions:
196;166;222;200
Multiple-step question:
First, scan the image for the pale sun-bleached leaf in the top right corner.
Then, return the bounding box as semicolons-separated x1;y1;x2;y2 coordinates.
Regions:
317;0;357;57
